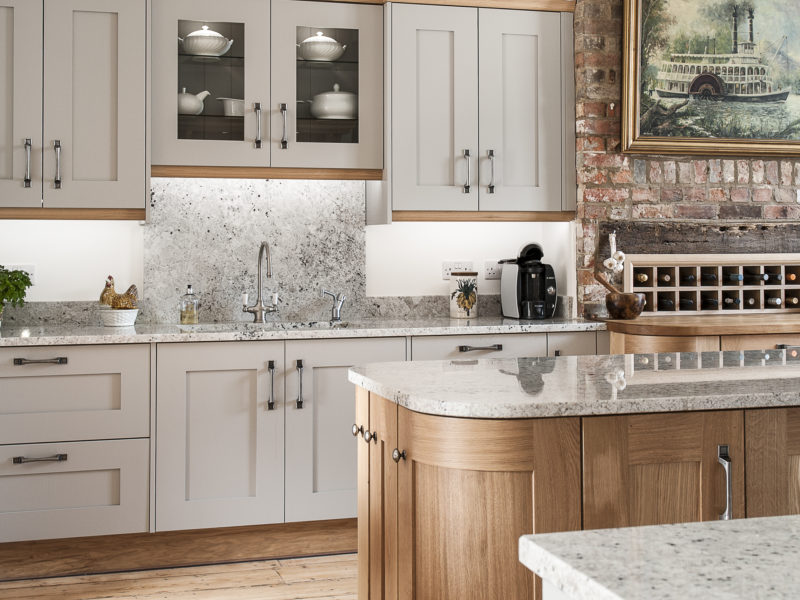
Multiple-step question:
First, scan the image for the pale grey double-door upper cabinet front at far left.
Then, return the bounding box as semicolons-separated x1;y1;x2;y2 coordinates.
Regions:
0;0;147;208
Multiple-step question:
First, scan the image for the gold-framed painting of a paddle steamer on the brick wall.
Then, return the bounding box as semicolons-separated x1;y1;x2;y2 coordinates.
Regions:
622;0;800;156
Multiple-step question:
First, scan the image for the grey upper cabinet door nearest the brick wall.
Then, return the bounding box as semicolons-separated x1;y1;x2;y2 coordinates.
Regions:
478;8;574;211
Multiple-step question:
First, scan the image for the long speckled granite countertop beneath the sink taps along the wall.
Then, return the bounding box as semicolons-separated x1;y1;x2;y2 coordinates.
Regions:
0;317;605;347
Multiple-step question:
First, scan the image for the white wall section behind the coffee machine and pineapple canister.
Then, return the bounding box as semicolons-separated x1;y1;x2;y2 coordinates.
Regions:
367;223;576;297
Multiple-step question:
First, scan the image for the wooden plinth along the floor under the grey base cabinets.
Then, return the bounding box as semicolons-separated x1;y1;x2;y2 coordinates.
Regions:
0;519;358;581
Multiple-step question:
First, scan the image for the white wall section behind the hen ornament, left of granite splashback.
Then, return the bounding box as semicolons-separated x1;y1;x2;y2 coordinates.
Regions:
0;221;143;302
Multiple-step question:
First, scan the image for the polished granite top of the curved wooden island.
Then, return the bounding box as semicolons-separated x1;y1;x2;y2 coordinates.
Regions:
349;350;800;419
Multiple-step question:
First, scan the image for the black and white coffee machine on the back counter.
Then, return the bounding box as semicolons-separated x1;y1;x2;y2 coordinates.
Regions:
499;244;558;319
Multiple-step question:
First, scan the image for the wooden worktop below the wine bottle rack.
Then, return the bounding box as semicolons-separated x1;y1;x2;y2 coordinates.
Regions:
606;314;800;336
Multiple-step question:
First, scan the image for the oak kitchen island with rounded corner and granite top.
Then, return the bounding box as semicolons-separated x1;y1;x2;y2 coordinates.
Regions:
350;351;800;600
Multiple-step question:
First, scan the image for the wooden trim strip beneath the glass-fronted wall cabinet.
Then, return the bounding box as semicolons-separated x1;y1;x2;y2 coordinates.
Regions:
155;165;383;181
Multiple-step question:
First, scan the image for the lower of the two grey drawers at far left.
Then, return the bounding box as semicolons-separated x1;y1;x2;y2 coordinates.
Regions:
0;439;150;542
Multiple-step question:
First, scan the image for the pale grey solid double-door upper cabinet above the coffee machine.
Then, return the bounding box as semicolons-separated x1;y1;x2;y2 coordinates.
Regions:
387;4;575;211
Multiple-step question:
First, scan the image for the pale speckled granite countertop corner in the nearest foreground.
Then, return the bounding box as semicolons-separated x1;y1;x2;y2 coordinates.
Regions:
519;515;800;600
